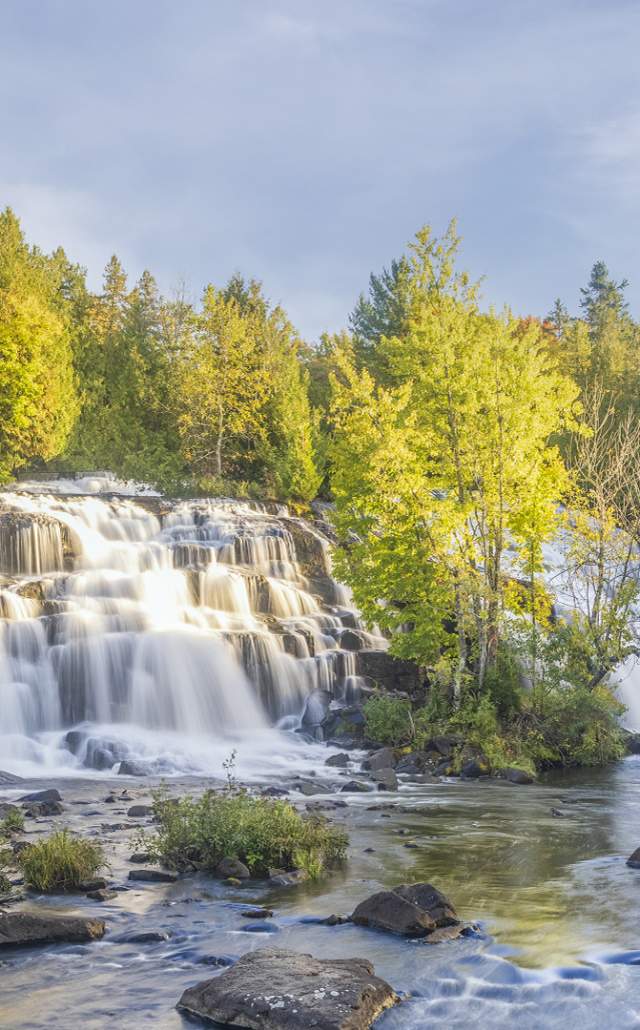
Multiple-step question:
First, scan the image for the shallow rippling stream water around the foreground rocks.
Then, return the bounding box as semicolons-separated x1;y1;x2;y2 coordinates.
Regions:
0;758;640;1030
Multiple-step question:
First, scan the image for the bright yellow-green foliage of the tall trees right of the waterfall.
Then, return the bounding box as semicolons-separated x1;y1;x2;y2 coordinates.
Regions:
331;225;577;698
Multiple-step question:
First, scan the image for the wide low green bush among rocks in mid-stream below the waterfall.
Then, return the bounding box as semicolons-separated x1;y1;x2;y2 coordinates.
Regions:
141;788;348;878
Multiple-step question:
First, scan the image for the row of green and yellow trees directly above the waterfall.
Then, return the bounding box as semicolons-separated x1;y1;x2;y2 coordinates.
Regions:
0;209;323;500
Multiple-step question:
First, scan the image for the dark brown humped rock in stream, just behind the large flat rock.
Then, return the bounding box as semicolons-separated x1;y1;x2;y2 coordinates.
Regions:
351;884;463;937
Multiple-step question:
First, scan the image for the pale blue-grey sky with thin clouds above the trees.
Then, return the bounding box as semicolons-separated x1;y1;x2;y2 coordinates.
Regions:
0;0;640;340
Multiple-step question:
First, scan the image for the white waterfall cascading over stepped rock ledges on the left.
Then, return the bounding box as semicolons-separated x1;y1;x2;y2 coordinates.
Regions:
0;481;383;775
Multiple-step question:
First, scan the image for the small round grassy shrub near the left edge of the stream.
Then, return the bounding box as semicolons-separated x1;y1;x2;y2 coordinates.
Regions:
18;830;106;892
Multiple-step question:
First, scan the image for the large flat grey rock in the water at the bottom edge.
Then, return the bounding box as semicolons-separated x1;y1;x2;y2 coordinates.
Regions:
178;949;393;1030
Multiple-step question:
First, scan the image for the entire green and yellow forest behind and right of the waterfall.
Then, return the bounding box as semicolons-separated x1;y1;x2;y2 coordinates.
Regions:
0;209;640;769
